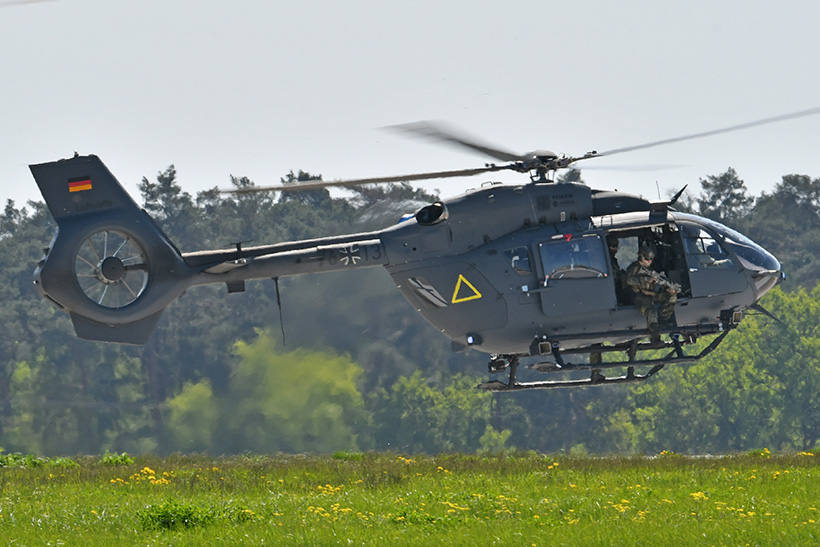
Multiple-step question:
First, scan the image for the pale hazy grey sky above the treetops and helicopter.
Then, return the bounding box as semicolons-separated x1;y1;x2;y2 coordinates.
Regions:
0;0;820;210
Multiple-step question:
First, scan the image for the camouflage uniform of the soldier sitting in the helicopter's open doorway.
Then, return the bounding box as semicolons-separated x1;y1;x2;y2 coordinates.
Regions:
626;256;679;340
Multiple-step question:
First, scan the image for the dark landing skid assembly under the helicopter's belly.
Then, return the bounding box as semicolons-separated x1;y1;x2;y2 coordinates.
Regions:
476;330;729;391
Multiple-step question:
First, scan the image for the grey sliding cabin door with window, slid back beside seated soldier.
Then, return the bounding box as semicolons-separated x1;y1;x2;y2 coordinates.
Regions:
535;234;615;317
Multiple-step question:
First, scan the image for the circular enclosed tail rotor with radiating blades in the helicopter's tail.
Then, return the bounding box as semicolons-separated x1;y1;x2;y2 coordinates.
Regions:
74;230;149;309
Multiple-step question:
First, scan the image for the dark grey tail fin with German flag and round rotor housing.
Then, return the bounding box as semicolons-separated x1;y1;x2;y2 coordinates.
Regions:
30;156;192;344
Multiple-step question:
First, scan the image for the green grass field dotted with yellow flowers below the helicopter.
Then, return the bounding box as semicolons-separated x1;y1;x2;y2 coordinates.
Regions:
0;449;820;546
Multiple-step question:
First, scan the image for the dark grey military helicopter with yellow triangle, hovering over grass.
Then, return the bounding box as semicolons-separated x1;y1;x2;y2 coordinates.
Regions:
30;109;820;391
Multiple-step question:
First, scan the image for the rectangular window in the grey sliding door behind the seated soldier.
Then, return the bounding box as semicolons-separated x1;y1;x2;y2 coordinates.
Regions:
538;234;608;285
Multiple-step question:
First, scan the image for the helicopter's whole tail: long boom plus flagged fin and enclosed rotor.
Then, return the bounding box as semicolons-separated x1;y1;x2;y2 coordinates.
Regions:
31;156;388;344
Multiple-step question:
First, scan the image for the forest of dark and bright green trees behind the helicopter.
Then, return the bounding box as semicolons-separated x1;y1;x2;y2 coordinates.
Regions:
0;166;820;456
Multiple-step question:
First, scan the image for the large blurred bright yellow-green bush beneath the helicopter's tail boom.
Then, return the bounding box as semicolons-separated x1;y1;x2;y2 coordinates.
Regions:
219;331;366;453
